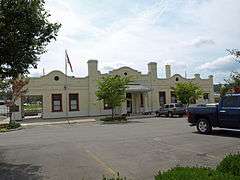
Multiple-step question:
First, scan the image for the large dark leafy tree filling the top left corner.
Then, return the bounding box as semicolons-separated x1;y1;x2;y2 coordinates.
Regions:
0;0;61;79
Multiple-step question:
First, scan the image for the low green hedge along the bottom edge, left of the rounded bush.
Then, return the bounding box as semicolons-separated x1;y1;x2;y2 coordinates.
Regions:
155;167;240;180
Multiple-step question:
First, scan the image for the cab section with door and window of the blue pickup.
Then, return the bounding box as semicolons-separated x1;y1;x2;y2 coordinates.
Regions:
219;95;240;128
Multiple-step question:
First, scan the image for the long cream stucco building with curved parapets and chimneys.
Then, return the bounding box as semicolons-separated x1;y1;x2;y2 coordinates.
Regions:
18;60;214;118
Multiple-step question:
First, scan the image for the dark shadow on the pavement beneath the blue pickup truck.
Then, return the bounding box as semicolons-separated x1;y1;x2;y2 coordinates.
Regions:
193;129;240;138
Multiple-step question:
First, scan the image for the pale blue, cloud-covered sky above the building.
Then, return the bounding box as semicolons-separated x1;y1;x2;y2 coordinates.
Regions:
30;0;240;83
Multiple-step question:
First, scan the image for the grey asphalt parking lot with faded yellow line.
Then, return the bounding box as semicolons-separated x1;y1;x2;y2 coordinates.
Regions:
0;117;240;180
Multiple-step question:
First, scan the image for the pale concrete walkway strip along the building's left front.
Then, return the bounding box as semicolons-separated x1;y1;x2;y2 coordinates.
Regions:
21;119;96;127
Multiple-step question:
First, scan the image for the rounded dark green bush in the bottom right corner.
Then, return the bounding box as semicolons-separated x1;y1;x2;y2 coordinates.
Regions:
217;153;240;176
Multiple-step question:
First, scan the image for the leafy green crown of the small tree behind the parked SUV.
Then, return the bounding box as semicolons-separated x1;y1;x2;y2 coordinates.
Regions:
174;82;202;106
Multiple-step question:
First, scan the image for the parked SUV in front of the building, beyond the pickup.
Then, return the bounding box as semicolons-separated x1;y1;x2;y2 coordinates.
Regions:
156;103;186;117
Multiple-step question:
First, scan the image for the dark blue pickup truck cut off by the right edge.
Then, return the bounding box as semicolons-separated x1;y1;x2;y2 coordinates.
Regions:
187;94;240;134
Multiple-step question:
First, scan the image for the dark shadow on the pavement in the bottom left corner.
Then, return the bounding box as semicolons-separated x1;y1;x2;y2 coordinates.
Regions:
0;163;43;180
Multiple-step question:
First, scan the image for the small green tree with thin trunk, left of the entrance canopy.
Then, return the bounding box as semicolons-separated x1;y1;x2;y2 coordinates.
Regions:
96;76;129;119
